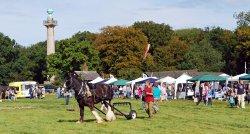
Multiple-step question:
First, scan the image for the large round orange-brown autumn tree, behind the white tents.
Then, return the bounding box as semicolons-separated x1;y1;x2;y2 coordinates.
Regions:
95;26;147;79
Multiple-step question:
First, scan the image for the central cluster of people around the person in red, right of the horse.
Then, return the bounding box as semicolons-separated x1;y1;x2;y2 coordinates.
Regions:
110;81;177;117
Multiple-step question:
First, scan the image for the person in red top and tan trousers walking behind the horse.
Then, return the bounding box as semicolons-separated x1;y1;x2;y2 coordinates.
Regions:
144;81;154;117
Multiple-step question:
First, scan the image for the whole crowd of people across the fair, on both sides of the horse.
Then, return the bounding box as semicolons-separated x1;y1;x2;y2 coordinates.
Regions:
1;80;250;118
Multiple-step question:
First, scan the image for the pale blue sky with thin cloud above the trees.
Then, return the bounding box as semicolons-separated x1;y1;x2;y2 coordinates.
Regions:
0;0;250;46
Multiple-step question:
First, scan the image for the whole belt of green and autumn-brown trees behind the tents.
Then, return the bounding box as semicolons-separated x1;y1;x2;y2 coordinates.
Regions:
0;12;250;84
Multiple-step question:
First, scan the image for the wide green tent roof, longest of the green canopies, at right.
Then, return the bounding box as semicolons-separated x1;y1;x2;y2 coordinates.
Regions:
188;74;226;82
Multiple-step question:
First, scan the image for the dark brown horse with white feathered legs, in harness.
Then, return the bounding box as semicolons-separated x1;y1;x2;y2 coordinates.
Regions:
65;72;116;123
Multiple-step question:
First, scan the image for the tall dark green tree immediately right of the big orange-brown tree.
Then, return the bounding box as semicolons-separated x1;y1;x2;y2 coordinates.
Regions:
133;21;175;71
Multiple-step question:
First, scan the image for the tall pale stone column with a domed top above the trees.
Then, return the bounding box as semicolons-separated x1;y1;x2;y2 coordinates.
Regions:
43;9;57;55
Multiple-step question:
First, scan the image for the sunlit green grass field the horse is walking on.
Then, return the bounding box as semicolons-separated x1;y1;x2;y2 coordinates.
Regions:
0;95;250;134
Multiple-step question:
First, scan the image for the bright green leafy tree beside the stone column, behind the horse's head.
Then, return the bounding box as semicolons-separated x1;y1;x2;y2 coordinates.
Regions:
47;34;99;78
